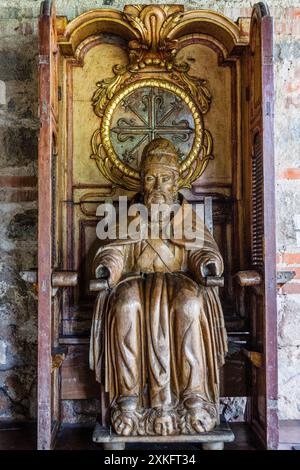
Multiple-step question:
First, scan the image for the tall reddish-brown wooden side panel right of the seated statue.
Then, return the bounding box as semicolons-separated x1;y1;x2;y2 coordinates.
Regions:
248;2;278;449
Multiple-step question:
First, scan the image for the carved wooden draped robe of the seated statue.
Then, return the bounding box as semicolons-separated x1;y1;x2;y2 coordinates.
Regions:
90;198;227;430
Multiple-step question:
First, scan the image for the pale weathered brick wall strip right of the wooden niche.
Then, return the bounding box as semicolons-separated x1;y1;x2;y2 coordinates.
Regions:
274;2;300;419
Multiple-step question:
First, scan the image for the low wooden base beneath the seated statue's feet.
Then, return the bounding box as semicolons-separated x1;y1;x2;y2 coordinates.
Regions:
93;423;234;450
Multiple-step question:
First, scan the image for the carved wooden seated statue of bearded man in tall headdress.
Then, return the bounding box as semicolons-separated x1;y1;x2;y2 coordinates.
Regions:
90;138;227;436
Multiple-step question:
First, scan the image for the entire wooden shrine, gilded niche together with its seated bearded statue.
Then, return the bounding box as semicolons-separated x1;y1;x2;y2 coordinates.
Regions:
36;0;278;450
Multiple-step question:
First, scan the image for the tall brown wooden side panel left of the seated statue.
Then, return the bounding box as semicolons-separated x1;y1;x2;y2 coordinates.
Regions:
38;1;59;449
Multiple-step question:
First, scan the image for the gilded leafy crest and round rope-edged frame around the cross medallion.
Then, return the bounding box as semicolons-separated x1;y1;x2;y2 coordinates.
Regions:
91;5;213;191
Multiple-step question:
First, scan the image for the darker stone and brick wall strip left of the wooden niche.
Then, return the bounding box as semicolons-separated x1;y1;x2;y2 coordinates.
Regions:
0;2;39;420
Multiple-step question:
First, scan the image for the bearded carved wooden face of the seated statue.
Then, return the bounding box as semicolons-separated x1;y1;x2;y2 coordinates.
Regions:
143;164;178;208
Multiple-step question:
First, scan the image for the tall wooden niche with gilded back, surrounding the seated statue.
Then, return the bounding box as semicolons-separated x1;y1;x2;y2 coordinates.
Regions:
38;1;278;449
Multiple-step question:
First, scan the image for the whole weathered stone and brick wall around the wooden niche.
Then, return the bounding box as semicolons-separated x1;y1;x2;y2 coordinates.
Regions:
0;0;300;420
